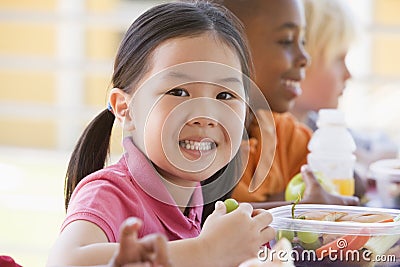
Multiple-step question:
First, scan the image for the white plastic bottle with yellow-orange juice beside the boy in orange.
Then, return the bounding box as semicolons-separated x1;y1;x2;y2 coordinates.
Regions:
307;109;356;196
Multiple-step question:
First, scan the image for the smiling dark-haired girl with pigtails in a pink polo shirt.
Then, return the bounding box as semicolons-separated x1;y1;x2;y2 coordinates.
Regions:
48;1;274;266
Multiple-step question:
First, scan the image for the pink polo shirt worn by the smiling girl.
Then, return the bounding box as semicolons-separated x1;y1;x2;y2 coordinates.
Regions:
61;138;203;242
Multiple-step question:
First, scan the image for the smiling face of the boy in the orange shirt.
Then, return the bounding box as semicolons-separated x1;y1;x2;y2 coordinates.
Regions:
241;0;309;112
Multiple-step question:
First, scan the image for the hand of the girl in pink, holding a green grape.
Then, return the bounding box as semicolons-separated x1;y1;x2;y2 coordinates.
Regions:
198;201;275;266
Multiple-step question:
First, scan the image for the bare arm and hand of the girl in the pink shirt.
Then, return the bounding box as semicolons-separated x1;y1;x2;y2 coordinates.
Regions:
47;202;274;267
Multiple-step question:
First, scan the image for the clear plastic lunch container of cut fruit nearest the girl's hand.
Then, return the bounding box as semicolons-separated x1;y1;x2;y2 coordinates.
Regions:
268;204;400;266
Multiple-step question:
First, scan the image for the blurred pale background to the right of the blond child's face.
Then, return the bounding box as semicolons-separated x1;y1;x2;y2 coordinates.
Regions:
340;0;400;146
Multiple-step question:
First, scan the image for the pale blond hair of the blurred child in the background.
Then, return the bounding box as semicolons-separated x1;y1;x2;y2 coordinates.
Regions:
303;0;357;62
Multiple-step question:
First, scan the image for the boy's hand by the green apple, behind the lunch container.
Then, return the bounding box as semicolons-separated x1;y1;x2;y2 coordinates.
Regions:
300;165;360;206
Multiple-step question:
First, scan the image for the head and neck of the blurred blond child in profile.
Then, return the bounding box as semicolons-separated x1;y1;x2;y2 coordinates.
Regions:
291;0;356;126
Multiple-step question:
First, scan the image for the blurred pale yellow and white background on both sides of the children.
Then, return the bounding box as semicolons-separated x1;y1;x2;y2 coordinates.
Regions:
0;0;400;267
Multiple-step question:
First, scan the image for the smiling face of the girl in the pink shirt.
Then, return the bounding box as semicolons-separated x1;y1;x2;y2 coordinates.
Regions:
125;33;246;186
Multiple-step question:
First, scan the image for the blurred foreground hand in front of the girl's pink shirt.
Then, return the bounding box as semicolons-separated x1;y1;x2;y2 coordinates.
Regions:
108;218;171;267
